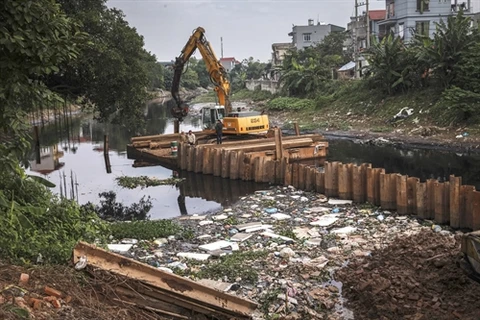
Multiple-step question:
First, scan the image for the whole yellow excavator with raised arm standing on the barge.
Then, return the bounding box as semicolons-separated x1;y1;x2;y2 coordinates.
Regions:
171;27;269;135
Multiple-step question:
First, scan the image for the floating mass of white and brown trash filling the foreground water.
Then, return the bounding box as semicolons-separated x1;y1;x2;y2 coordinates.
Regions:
109;186;462;319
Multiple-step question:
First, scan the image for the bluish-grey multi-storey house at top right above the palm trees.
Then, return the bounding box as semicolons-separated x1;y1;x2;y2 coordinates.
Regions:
379;0;480;42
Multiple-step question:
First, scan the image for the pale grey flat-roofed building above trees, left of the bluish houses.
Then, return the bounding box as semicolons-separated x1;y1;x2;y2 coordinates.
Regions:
288;19;345;50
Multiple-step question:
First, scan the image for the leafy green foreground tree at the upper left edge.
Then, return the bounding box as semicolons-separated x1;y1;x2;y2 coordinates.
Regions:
0;0;86;175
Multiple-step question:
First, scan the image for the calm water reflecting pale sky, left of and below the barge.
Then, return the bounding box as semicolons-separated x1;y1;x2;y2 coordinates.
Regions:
28;104;268;219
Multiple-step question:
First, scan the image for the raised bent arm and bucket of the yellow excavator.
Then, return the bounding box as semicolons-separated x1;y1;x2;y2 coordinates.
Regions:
171;27;232;121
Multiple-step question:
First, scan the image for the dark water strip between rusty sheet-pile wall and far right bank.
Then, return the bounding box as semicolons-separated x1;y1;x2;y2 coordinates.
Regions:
327;140;480;190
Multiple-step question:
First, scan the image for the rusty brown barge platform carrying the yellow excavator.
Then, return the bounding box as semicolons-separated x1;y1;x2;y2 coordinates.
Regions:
127;128;328;178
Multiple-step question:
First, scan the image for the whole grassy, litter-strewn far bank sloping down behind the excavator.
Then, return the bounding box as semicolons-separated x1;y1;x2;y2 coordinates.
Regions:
193;86;480;153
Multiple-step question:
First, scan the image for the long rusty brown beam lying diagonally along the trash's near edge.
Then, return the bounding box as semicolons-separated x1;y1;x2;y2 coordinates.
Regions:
73;242;257;319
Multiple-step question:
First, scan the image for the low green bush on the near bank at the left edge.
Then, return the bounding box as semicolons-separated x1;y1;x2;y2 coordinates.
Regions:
0;177;108;264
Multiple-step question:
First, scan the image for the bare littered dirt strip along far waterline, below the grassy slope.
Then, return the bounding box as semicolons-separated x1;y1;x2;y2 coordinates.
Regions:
268;111;480;153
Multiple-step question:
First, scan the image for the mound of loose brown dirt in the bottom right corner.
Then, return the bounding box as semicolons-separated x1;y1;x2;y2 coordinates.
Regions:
337;232;480;320
